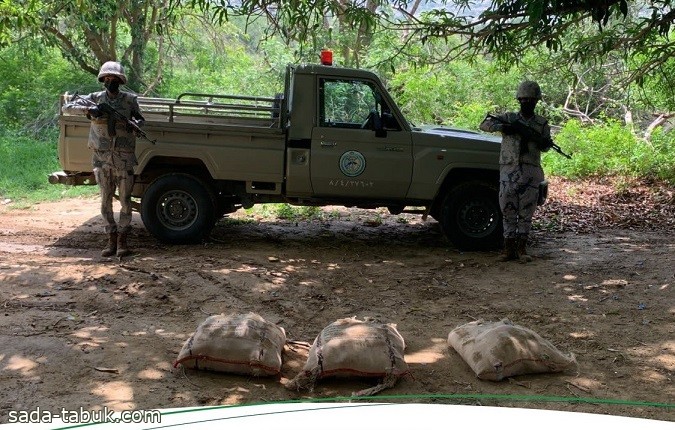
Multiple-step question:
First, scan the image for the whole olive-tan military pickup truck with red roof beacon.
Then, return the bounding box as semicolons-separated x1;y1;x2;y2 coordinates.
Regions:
49;58;502;250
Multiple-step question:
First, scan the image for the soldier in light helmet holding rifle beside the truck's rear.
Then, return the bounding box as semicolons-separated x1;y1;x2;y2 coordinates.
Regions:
63;61;145;257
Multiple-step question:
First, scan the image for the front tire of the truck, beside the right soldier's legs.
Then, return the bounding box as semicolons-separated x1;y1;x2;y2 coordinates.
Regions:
439;181;504;251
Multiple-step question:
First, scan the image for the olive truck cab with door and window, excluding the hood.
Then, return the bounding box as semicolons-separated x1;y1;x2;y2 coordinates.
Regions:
286;65;413;204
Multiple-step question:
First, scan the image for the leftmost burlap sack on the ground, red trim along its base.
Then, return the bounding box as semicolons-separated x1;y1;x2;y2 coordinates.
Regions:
173;312;286;376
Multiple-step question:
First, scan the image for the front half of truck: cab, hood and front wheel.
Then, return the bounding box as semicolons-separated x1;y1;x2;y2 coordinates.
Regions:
286;61;501;249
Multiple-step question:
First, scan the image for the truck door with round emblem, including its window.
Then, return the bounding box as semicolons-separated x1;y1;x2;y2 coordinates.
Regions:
310;77;413;199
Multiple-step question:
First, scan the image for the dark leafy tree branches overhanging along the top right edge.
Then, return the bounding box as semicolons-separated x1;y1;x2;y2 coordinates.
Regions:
171;0;675;89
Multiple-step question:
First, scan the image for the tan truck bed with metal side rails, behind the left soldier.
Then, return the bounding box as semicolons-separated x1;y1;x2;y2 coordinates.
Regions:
58;93;285;183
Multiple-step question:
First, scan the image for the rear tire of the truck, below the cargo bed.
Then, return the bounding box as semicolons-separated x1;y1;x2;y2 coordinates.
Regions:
141;173;216;244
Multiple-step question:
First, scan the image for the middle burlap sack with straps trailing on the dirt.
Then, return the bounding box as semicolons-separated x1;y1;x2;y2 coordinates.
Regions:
286;317;409;396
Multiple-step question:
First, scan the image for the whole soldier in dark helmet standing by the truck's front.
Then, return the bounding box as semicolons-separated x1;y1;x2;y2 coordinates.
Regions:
480;81;553;263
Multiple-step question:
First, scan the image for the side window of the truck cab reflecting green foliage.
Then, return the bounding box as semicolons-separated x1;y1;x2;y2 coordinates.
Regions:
319;79;380;128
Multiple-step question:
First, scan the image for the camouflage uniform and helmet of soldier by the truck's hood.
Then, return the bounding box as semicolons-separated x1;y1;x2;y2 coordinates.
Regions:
480;81;551;261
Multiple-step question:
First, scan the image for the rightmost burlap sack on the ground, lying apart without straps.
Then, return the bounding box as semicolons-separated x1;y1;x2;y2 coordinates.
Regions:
448;319;576;381
